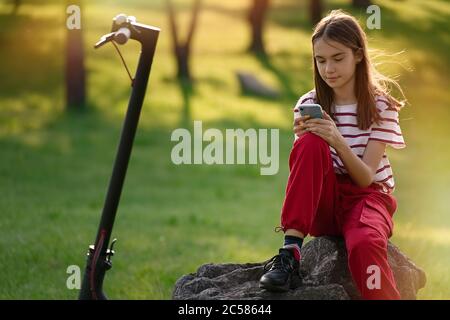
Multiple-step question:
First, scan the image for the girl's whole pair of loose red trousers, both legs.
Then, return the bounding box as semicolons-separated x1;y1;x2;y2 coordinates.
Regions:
281;133;400;299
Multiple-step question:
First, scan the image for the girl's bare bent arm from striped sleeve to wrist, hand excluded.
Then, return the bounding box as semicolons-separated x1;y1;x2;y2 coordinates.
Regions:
334;139;386;188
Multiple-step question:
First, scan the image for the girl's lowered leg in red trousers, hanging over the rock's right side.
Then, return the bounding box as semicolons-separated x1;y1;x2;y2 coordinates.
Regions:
343;197;400;299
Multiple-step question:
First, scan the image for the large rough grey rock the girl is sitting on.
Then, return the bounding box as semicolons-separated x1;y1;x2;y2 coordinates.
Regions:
173;237;426;300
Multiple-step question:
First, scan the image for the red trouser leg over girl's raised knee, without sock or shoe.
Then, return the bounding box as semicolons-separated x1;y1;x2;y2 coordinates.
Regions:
281;132;339;236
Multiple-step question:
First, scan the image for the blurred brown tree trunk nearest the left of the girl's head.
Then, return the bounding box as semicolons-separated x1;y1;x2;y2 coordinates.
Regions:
248;0;270;55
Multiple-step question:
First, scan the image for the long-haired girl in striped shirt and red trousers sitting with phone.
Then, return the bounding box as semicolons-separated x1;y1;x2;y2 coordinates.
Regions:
260;10;406;299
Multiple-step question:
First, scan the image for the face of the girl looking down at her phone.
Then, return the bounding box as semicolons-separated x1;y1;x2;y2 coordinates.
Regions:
313;37;362;89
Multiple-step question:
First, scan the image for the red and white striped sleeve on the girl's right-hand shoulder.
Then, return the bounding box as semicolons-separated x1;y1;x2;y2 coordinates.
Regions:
369;98;406;149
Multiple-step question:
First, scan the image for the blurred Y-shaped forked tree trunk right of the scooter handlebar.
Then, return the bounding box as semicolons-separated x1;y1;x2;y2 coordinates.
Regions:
166;0;201;82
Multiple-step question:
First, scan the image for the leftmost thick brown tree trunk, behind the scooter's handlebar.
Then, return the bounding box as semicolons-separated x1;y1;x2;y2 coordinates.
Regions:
65;0;86;108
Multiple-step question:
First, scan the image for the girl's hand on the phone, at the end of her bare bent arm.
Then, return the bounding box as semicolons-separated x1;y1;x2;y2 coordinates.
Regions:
304;110;344;149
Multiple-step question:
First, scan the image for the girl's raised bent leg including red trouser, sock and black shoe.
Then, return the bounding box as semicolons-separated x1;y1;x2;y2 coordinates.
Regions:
259;132;338;291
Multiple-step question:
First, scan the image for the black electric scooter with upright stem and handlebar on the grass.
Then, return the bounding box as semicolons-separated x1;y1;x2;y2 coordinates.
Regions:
79;14;160;300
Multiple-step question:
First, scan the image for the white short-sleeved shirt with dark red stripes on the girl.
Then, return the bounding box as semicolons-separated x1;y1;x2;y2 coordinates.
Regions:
295;90;406;194
